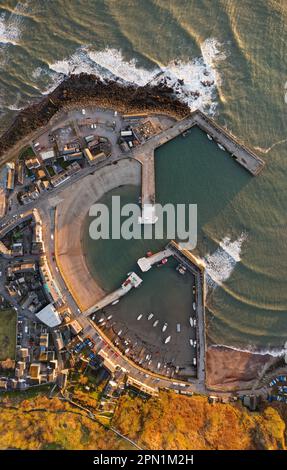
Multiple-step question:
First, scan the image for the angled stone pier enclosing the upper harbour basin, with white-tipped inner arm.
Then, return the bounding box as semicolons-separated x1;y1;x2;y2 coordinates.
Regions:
134;110;265;224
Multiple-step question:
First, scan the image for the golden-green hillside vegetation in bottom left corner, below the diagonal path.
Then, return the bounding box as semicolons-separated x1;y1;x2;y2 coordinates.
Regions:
0;396;131;450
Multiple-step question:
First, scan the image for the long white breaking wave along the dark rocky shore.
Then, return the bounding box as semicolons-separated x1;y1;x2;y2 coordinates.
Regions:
42;38;226;114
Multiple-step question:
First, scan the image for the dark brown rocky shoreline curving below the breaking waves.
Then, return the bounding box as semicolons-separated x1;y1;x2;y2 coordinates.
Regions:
0;73;190;156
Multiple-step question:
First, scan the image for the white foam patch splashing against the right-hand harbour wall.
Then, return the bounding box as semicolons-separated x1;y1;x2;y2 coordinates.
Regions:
205;232;247;289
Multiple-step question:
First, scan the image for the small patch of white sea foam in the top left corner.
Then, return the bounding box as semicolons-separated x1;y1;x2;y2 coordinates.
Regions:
0;2;27;46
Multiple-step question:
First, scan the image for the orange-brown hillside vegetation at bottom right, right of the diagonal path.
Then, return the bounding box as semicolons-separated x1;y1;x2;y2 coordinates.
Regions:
113;393;286;450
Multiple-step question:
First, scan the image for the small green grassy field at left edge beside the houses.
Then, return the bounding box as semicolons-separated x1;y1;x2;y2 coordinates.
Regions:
0;309;17;361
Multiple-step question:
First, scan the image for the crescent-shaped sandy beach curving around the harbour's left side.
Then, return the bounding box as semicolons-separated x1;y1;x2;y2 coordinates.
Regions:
55;159;141;310
